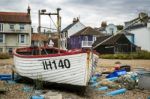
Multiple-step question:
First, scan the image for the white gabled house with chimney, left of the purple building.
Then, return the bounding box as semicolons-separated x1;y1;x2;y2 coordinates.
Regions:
61;18;85;49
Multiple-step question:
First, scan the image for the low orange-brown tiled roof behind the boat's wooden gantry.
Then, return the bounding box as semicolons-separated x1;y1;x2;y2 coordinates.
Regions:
31;33;49;41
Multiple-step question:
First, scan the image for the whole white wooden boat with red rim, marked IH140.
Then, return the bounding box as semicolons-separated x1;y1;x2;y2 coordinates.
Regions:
13;47;98;86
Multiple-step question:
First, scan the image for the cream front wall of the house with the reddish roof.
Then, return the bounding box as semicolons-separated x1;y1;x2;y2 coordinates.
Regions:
0;23;31;52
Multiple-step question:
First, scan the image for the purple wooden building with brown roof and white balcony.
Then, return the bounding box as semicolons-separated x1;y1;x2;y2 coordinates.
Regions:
68;27;103;49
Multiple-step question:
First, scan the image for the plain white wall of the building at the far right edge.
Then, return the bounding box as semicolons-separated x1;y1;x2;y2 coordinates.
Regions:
127;27;150;51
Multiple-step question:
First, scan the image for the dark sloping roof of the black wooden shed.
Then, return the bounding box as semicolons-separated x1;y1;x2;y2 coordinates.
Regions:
92;33;134;48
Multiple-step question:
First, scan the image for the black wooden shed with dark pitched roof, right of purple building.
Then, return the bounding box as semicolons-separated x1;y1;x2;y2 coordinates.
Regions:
92;33;136;54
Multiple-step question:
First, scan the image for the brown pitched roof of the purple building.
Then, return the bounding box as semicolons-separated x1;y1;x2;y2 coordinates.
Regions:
72;27;104;36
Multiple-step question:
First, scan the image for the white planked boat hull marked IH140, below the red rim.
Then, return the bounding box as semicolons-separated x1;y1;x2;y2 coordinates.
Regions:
14;50;98;86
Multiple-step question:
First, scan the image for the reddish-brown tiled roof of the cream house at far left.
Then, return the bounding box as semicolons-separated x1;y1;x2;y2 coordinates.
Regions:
0;12;31;24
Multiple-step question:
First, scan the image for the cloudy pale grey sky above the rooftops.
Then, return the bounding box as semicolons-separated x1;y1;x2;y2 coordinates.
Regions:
0;0;150;31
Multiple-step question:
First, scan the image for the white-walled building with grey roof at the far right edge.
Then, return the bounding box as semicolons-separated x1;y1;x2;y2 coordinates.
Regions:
125;12;150;51
